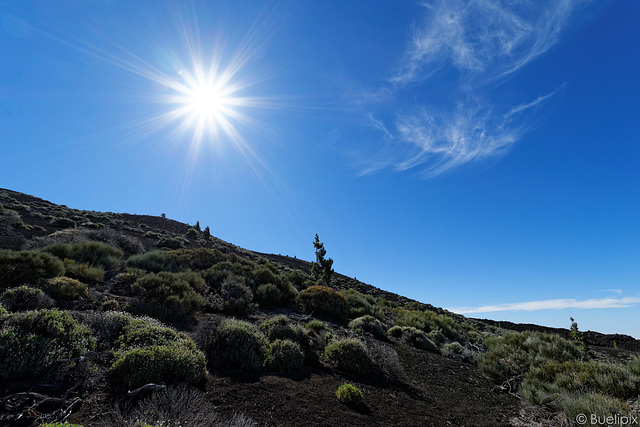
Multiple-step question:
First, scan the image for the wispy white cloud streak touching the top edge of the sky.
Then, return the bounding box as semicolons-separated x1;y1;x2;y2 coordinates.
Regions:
391;0;578;84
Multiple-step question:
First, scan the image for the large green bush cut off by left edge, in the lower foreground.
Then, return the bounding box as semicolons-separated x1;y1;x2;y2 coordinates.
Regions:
0;310;95;379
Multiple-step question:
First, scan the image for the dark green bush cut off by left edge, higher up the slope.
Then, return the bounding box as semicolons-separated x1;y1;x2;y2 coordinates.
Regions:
0;250;65;289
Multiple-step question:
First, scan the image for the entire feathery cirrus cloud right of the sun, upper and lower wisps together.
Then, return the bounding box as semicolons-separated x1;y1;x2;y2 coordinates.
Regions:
364;0;585;176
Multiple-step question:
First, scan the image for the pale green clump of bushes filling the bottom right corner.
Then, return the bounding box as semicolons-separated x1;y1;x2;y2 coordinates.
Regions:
478;332;640;418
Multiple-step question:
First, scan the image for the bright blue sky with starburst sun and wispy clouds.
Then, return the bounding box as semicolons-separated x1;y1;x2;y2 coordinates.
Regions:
0;0;640;338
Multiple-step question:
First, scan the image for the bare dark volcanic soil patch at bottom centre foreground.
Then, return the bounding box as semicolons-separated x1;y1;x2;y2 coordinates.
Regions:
207;346;521;426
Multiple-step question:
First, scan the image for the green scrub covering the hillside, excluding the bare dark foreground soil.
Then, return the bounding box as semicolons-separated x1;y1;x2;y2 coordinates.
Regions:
0;192;640;426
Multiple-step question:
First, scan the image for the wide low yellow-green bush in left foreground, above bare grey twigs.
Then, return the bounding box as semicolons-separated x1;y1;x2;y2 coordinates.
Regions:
111;342;206;388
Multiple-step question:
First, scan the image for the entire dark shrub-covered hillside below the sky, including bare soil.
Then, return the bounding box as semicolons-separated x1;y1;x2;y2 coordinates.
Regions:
0;190;640;426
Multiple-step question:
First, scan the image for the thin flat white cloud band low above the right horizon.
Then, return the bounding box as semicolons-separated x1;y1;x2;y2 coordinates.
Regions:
448;296;640;314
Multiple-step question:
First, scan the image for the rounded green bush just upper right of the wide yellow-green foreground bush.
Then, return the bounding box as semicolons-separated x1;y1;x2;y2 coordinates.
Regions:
214;319;267;371
